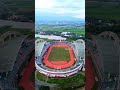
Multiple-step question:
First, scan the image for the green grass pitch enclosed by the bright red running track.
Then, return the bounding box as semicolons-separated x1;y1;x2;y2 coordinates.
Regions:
48;47;70;61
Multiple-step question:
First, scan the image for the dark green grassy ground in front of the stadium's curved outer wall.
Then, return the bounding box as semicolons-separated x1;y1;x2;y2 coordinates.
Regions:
36;72;85;90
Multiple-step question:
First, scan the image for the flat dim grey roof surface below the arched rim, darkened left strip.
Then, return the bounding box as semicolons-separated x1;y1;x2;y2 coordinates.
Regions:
0;35;26;72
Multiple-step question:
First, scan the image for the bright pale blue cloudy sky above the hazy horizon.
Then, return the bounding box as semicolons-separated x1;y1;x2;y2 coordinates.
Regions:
35;0;85;20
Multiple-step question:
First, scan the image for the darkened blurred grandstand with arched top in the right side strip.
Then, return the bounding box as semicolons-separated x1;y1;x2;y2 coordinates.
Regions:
86;31;120;90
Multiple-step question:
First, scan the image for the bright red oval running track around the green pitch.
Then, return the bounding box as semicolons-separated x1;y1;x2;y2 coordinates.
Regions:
43;43;75;69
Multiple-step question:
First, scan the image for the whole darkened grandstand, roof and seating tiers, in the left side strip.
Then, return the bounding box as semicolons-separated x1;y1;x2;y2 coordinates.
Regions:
0;31;34;90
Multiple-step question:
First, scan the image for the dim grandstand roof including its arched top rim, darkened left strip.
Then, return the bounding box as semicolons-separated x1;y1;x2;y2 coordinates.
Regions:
0;32;26;75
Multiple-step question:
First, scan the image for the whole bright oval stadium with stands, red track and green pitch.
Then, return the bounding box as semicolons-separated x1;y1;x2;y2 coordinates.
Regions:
35;39;85;77
